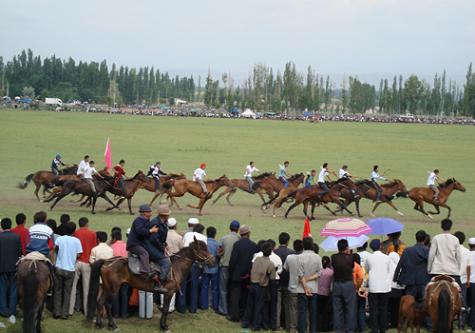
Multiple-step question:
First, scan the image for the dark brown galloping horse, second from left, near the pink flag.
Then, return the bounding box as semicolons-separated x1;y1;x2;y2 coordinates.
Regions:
45;177;118;214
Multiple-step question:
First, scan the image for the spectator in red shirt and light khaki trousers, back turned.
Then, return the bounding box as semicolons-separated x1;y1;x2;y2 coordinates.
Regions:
69;217;97;316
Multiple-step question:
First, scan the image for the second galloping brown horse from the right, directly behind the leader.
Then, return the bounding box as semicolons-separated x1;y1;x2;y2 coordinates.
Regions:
356;179;407;216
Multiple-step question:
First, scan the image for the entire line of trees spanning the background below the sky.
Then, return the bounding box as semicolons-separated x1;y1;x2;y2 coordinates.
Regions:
0;50;475;117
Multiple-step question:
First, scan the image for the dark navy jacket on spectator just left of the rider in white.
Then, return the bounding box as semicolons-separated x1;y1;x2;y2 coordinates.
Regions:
394;244;430;286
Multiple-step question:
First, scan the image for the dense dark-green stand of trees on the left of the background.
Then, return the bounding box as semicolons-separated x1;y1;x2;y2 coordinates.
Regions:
0;50;195;105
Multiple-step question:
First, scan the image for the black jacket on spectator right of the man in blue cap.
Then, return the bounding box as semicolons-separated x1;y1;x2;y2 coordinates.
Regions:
229;238;257;282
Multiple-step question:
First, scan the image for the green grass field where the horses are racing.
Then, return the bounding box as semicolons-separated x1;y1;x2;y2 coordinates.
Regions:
0;110;475;332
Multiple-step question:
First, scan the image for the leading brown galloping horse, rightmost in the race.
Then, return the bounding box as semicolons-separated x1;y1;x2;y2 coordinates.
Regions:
409;178;466;219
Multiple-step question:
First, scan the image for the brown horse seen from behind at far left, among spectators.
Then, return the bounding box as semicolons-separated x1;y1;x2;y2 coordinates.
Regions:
17;252;52;333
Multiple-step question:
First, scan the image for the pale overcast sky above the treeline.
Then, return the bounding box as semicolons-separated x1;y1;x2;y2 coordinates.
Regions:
0;0;475;81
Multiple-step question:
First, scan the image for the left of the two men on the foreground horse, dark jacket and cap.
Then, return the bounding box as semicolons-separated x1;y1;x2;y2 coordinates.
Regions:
127;204;167;293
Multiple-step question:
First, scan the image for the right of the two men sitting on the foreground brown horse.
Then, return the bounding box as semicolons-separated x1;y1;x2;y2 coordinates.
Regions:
145;204;171;286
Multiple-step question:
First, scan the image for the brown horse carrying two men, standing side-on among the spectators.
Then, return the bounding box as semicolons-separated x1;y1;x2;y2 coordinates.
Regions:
87;238;215;331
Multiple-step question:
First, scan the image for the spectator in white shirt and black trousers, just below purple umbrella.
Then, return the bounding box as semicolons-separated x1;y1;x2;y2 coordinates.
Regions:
365;239;392;333
